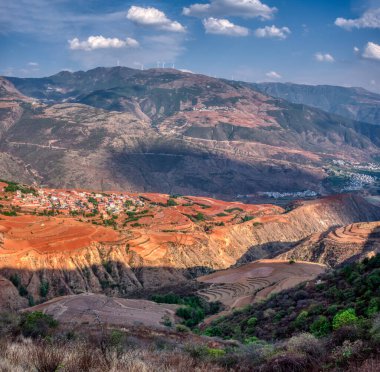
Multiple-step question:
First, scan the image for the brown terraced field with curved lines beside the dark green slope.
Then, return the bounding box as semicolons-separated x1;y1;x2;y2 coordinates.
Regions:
197;260;325;309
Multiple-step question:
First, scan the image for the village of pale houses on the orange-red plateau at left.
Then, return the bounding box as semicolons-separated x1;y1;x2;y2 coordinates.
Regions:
12;189;144;218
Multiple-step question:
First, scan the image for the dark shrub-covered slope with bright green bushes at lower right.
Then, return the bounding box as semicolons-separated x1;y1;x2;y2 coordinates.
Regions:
205;254;380;341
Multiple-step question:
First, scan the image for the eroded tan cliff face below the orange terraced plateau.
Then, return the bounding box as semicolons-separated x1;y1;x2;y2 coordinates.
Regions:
0;195;380;306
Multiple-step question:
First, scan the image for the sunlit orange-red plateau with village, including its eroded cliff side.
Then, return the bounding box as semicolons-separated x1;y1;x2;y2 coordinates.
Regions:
0;182;380;306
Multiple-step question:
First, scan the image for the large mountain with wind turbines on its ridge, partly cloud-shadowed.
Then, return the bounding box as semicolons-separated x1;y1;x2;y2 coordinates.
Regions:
0;67;380;199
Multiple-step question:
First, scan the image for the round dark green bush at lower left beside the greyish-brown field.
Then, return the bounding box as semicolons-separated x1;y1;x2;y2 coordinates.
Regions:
20;311;58;338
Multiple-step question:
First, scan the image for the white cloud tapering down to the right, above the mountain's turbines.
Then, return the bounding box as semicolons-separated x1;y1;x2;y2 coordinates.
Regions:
127;6;186;32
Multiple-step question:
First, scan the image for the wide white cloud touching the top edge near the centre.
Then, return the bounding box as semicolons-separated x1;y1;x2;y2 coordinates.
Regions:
183;0;277;19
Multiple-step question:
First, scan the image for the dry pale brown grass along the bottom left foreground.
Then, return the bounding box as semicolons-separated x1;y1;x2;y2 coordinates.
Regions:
0;338;224;372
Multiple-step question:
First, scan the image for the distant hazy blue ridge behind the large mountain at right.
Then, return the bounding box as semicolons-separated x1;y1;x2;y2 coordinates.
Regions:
254;83;380;125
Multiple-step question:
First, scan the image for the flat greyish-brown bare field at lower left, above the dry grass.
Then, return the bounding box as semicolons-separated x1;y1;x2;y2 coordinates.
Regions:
25;293;177;328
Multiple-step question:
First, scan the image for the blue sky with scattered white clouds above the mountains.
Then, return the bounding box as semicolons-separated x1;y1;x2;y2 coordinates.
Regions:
0;0;380;93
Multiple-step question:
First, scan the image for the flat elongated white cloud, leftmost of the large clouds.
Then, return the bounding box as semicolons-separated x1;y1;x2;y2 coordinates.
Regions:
69;35;139;51
